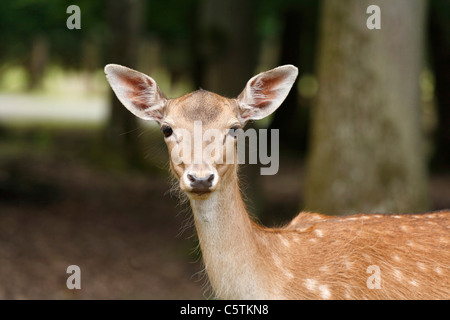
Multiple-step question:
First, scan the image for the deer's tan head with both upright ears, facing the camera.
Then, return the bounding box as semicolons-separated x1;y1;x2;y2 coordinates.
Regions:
105;64;297;198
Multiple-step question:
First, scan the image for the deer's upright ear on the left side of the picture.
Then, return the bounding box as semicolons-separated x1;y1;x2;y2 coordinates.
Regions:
105;64;167;122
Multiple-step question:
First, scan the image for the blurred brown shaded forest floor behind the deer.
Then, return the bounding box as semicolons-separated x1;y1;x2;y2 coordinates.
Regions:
0;126;450;299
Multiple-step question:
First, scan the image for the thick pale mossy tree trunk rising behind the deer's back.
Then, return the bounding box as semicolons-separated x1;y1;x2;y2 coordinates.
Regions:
305;0;428;214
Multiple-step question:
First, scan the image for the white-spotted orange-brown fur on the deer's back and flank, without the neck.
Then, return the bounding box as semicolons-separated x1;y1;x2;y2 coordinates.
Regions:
270;211;450;299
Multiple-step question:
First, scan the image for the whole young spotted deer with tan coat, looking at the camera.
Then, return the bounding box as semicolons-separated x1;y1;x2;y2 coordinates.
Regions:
105;64;450;300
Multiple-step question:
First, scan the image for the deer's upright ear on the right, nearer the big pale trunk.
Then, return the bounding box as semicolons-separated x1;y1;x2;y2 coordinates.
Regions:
237;65;298;125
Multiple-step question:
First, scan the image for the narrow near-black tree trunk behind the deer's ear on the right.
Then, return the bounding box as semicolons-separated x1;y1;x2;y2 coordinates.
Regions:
270;0;319;154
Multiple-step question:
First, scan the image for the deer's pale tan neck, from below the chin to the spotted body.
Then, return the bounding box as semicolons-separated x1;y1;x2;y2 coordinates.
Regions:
191;171;267;299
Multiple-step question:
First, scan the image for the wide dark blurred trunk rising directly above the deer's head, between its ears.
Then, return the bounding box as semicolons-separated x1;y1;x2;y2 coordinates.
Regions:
199;0;258;97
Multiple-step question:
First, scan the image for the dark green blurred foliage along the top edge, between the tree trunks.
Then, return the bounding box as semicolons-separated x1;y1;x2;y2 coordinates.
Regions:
0;0;315;69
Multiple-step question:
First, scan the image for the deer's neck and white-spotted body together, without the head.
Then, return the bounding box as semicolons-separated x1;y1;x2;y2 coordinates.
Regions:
191;160;450;299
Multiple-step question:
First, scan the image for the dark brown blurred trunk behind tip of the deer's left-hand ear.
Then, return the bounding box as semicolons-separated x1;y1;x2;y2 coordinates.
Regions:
104;0;143;166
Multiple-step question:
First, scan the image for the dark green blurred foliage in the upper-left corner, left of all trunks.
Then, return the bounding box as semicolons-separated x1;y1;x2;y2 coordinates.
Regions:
0;0;105;67
